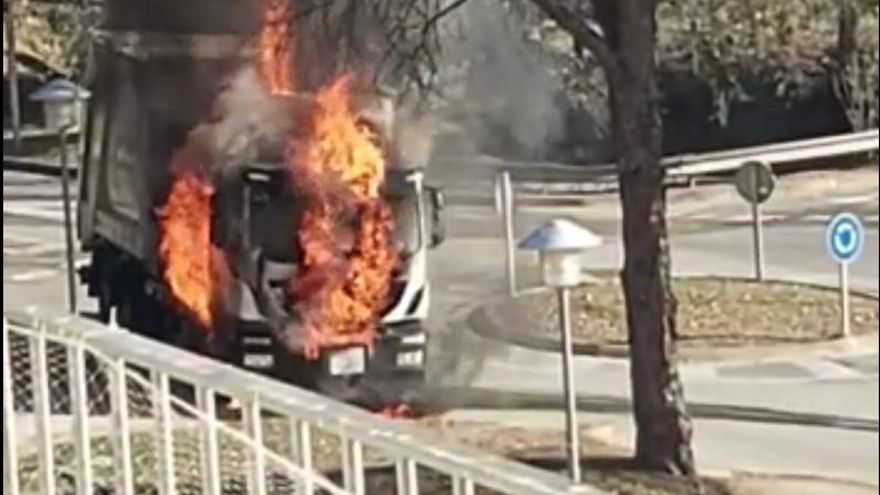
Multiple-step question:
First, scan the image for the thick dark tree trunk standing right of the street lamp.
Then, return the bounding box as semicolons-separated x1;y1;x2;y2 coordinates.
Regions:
609;0;695;475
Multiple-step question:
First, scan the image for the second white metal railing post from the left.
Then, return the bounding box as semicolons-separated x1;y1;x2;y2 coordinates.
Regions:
30;323;55;495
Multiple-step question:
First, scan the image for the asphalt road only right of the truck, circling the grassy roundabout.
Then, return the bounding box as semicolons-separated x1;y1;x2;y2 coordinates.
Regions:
422;168;878;486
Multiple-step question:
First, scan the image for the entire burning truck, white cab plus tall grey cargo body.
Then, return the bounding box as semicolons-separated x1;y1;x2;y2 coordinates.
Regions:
77;35;444;405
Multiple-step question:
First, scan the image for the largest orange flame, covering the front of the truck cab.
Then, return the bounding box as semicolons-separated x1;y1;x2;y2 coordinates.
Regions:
290;76;398;357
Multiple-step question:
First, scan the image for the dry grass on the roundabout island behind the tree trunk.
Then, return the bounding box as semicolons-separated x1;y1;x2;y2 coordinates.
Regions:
506;278;878;348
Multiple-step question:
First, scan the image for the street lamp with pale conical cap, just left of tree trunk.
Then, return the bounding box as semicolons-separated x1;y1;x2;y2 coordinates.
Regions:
519;219;602;483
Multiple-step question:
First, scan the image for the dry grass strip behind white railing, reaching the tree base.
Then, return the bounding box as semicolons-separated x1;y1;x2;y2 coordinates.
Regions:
19;418;733;495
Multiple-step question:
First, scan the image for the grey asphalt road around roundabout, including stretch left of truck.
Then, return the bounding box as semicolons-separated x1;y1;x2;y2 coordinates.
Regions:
3;168;878;485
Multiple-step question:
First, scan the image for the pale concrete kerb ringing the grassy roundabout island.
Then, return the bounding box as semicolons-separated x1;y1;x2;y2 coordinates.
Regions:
466;275;880;362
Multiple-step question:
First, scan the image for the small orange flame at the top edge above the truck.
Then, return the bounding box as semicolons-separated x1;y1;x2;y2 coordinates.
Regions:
259;0;293;95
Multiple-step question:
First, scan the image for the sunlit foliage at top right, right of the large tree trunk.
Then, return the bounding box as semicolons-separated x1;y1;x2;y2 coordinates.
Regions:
658;0;878;128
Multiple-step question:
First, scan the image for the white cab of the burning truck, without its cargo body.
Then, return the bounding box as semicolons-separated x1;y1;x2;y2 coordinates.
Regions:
213;159;445;402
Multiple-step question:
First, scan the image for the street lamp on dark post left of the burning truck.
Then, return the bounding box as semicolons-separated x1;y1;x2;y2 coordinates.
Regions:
30;79;89;313
